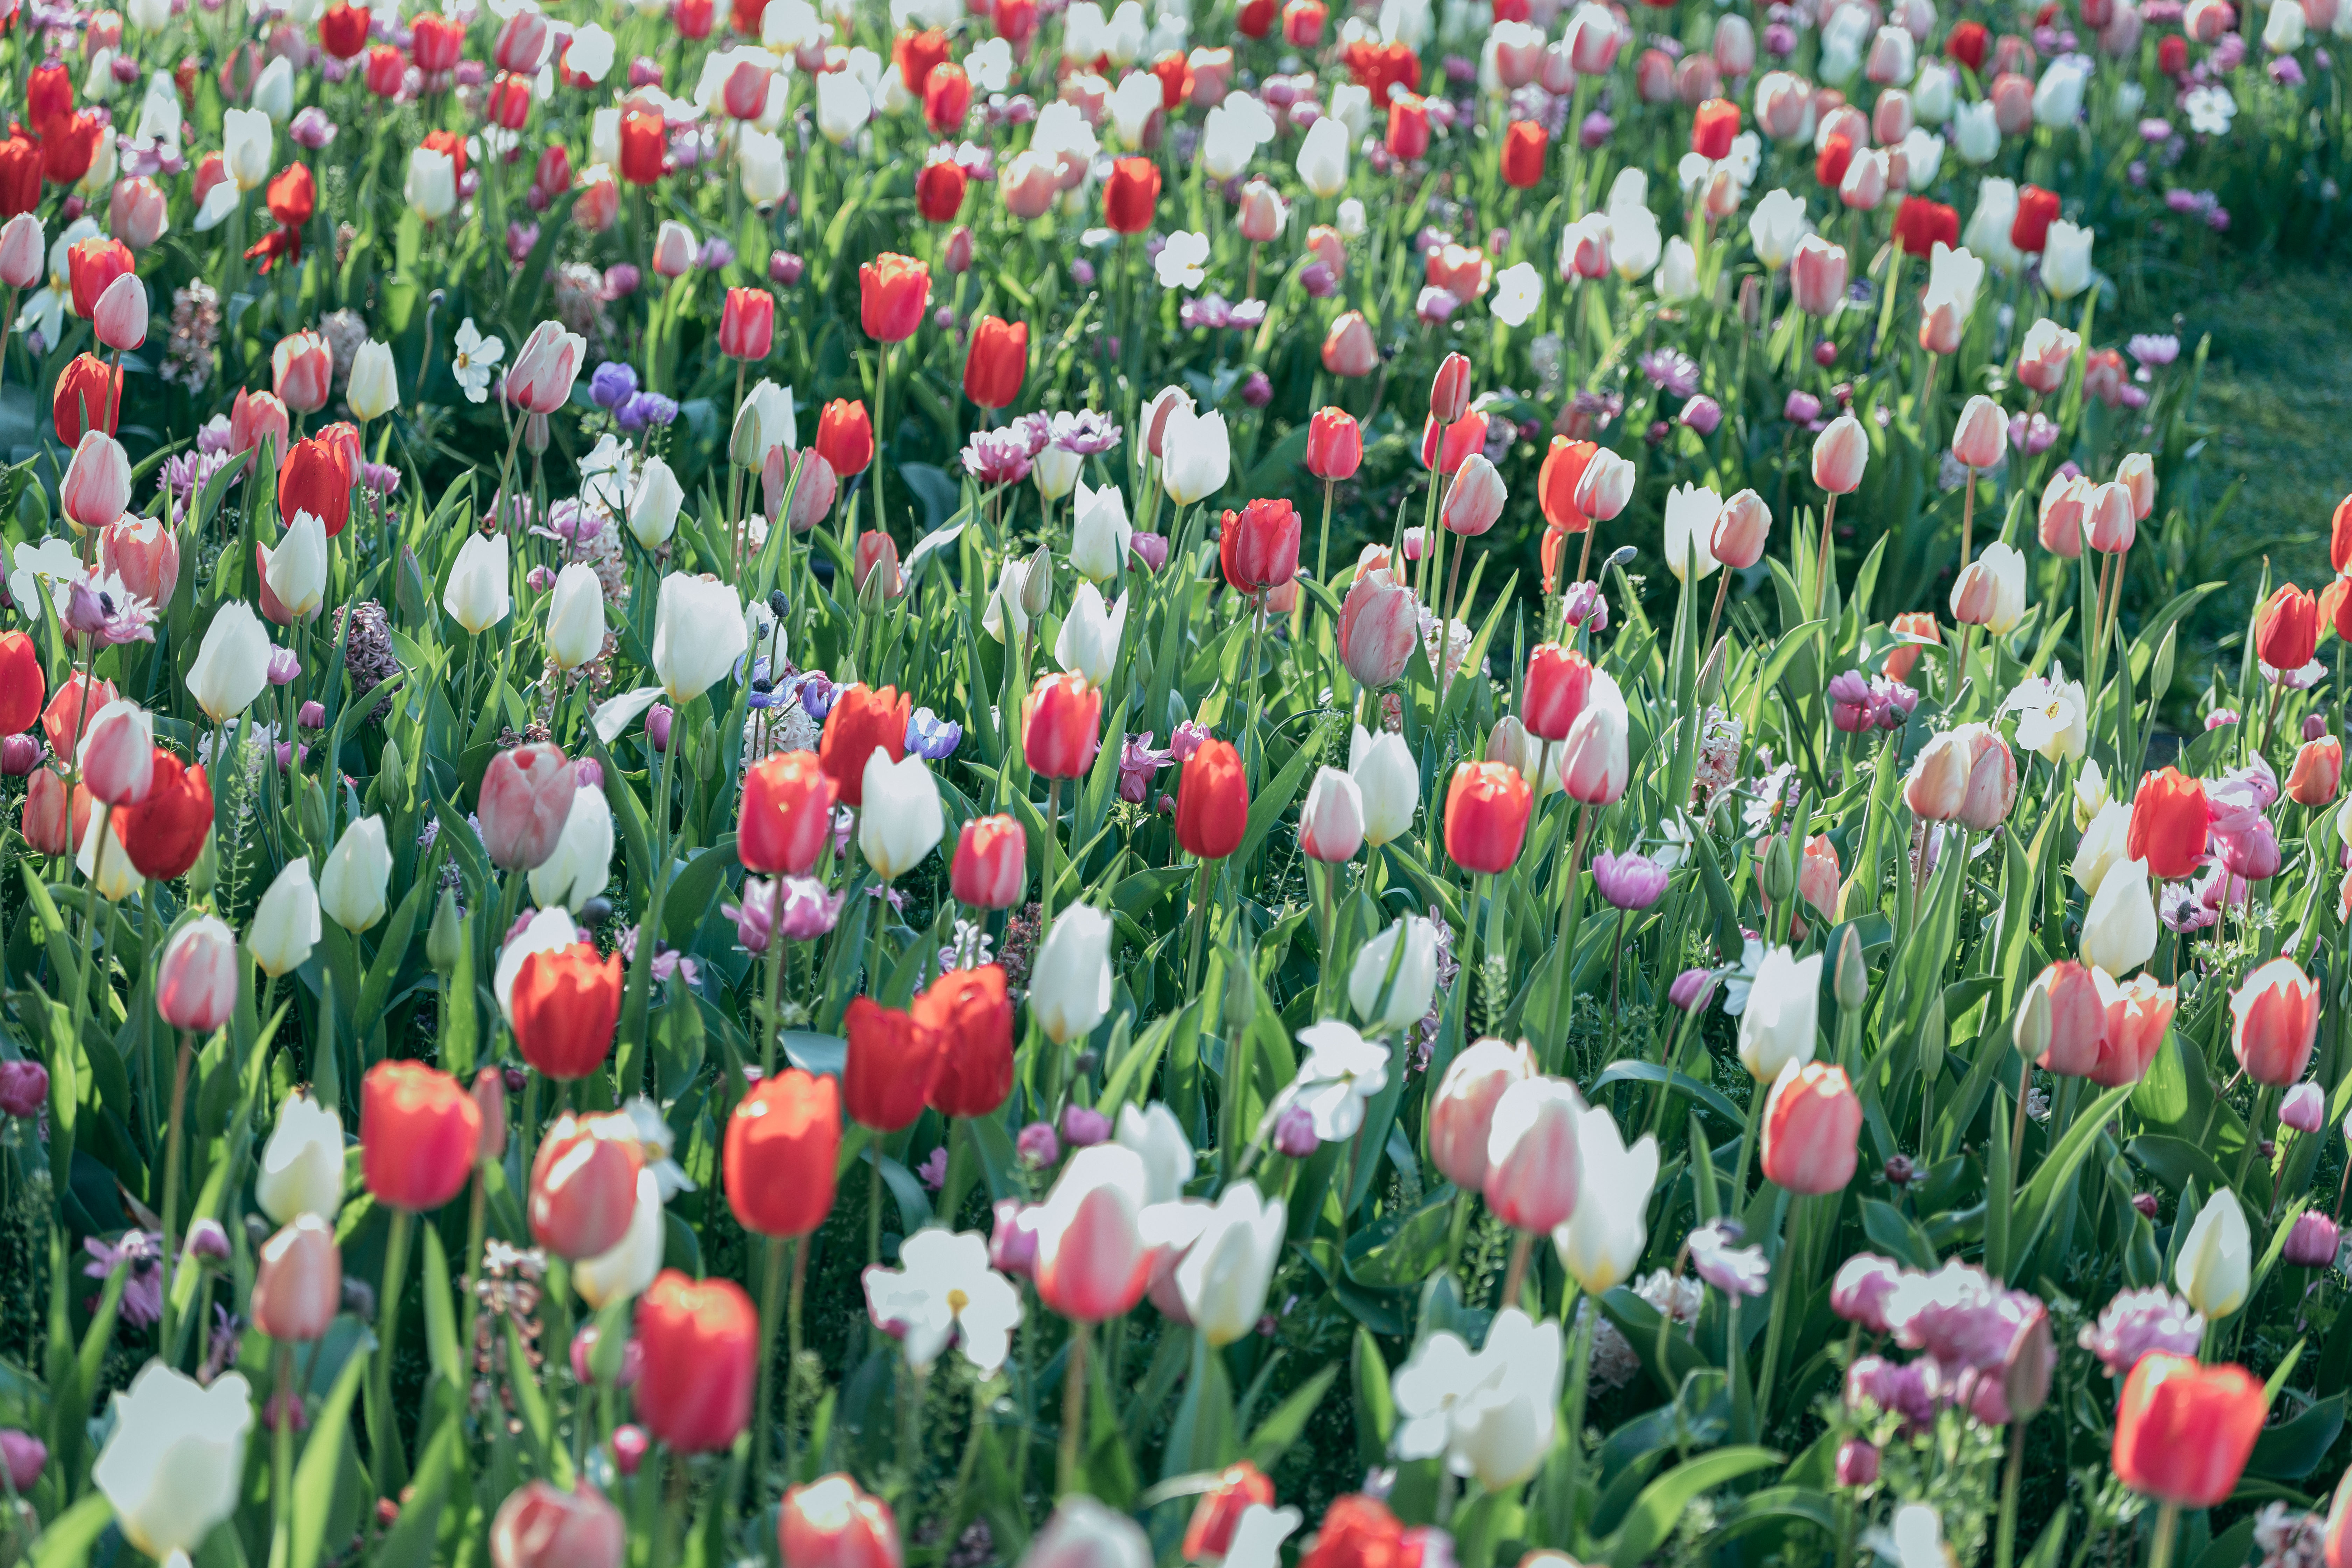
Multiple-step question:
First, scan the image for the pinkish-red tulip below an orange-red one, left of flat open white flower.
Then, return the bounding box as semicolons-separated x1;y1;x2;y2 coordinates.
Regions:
637;1269;752;1453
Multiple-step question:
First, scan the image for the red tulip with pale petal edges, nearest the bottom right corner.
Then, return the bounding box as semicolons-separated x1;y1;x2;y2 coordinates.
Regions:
2110;1349;2270;1514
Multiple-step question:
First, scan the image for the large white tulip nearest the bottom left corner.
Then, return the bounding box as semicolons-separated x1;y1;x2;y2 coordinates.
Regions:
89;1359;254;1563
